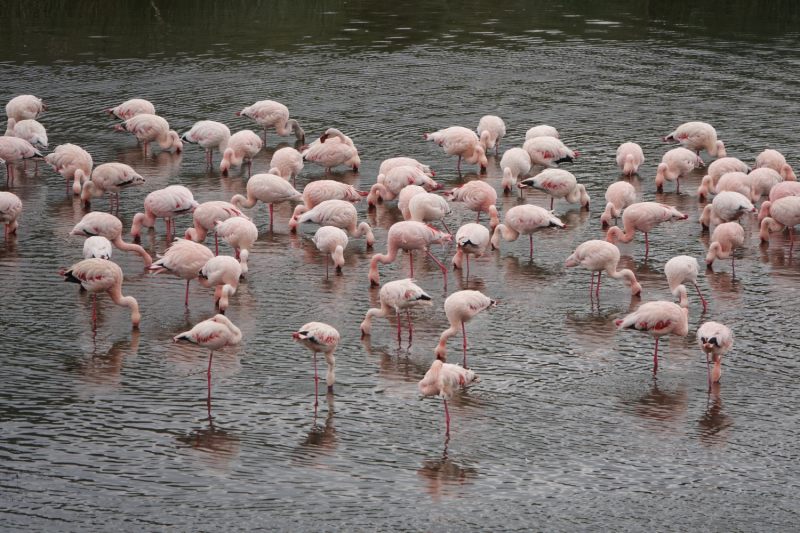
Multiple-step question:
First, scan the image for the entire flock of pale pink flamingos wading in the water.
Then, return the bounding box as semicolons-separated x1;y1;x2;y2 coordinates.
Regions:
0;90;800;434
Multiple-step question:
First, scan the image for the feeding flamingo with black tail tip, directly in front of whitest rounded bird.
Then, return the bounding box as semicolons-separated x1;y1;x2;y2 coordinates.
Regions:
59;258;142;328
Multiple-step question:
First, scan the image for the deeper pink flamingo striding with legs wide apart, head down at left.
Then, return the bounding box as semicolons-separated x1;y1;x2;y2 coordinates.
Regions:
369;220;453;285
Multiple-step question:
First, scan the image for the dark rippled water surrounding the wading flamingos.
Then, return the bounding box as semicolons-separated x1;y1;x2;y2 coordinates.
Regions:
0;1;800;532
